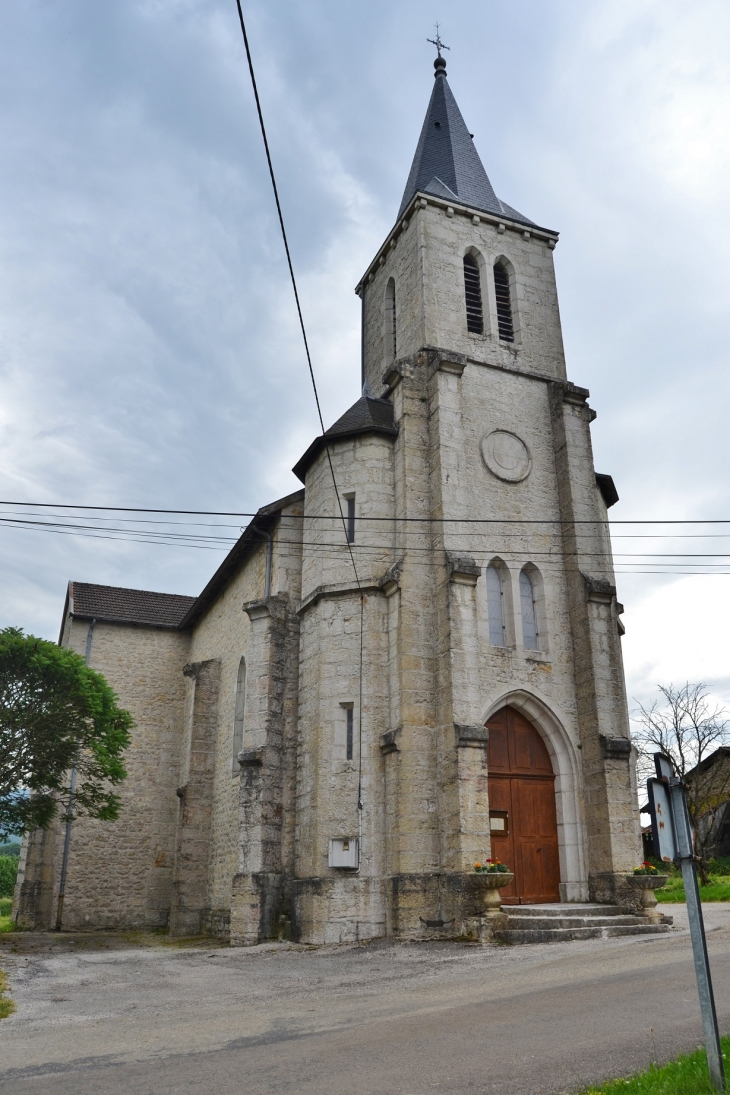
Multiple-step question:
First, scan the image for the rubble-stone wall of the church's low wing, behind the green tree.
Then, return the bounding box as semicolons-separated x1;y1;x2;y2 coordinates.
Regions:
26;620;189;930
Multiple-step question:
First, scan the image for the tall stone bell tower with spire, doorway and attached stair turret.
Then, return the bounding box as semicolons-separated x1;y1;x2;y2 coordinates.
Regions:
294;53;640;940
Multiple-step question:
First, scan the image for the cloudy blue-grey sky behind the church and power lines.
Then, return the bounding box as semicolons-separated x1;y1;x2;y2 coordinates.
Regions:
0;0;730;703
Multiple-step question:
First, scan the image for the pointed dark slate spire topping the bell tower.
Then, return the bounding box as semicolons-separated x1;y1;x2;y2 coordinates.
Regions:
398;51;533;224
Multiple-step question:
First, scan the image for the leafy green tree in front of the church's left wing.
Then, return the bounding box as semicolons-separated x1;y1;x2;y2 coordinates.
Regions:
0;627;134;833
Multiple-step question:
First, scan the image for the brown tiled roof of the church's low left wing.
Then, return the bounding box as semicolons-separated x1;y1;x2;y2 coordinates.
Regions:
69;581;196;627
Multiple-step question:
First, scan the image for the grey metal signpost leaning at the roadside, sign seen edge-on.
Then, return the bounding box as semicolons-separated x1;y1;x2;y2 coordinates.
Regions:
647;753;725;1092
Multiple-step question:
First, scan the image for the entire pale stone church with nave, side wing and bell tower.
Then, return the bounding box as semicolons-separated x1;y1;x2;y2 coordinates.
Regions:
15;57;641;945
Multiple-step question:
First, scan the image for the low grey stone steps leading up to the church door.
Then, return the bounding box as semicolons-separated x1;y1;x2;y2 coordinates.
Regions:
495;903;672;944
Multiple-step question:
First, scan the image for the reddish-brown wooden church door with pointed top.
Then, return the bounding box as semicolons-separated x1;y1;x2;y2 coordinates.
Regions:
487;706;560;904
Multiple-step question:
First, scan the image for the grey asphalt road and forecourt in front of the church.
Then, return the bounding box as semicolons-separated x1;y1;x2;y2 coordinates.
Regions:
0;906;730;1095
